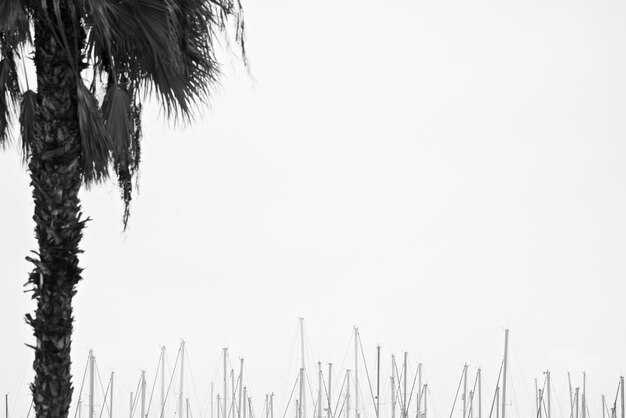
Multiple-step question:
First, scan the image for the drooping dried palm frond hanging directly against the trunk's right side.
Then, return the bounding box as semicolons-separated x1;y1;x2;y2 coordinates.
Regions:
77;79;111;186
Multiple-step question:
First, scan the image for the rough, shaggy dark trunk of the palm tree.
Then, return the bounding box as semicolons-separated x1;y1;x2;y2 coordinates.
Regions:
27;4;85;418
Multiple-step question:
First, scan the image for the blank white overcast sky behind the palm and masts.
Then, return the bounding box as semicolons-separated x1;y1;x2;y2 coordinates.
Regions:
0;0;626;418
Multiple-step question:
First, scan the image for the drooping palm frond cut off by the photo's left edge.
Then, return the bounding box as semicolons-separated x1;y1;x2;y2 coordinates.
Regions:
0;51;20;146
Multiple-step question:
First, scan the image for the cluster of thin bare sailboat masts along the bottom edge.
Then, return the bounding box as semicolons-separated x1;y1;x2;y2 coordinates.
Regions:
5;324;626;418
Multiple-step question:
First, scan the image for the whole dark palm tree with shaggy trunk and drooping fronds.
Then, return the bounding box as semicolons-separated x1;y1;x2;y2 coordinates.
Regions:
0;0;245;417
